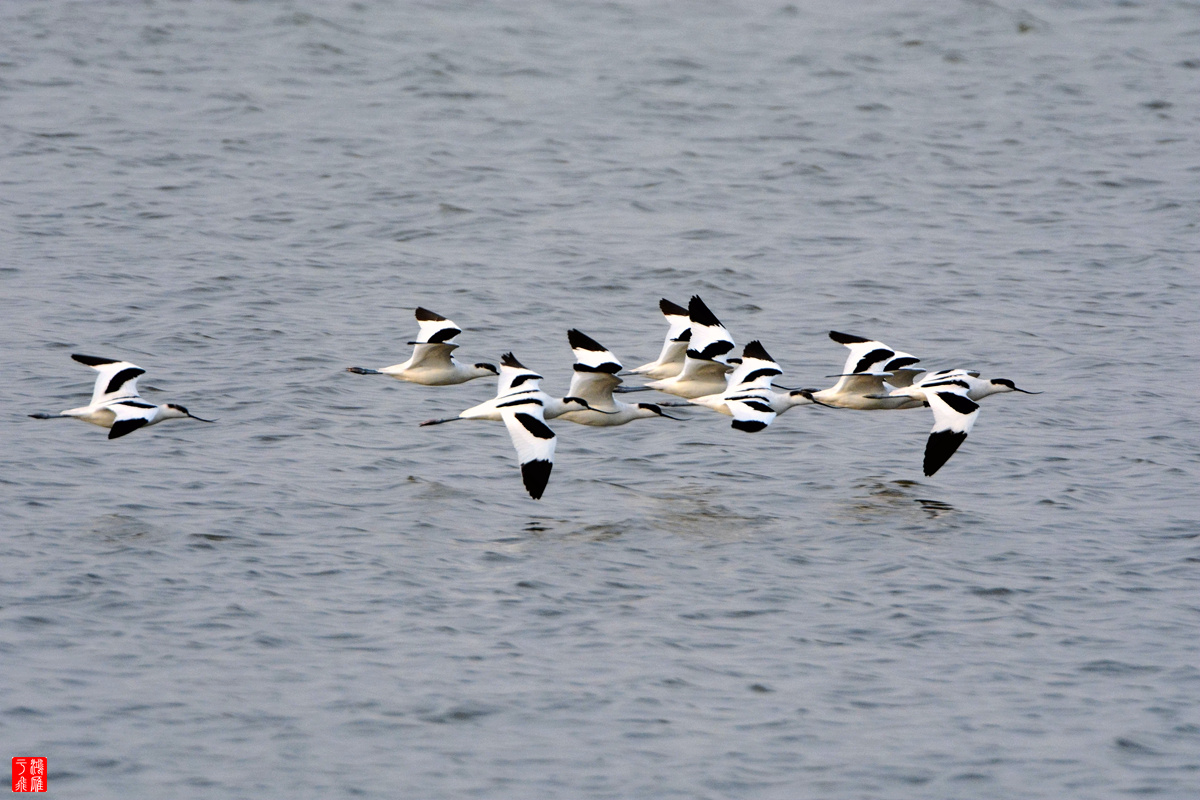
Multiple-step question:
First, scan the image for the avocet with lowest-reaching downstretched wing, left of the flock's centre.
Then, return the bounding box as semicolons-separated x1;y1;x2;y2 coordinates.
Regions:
421;353;600;500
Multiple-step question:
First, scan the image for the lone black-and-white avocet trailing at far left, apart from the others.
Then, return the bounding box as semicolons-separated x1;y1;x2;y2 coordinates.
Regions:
30;354;215;439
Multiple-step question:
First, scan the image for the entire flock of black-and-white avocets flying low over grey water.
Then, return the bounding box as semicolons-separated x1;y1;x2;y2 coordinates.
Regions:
30;296;1040;500
